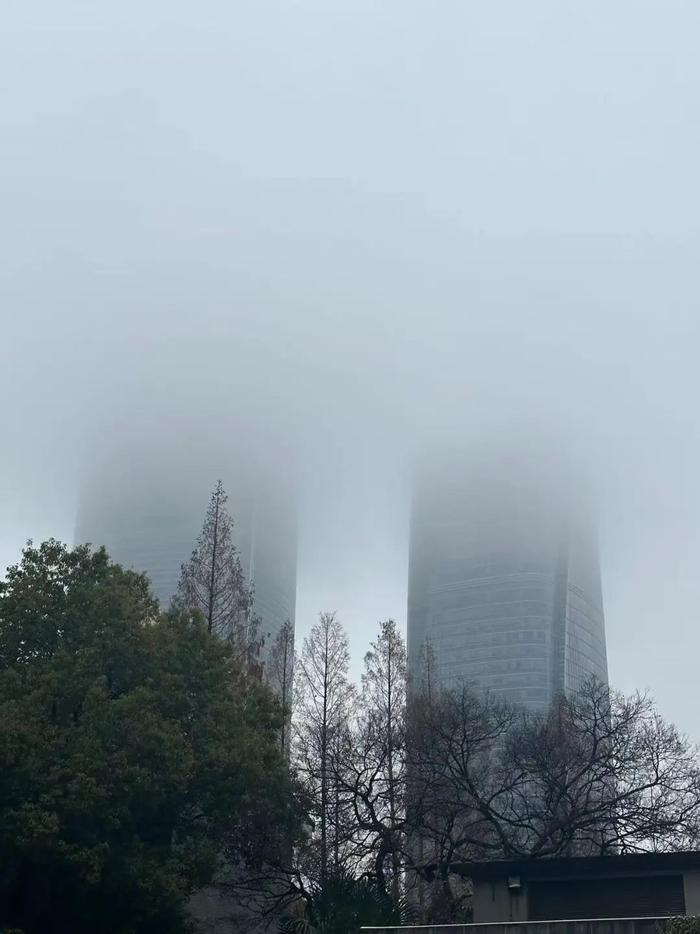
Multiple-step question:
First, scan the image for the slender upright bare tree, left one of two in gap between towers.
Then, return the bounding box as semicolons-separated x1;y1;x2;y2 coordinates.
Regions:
295;613;353;888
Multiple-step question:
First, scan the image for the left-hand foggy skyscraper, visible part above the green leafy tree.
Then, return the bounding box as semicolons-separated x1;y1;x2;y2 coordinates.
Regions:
75;441;297;660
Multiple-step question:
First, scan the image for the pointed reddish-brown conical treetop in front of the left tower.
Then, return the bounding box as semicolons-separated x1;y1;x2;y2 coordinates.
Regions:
176;480;262;667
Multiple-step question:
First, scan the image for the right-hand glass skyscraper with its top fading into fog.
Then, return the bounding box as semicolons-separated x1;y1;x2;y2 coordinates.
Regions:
408;445;607;710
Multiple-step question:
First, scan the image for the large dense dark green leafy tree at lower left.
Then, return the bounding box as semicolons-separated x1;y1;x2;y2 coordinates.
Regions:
0;541;289;934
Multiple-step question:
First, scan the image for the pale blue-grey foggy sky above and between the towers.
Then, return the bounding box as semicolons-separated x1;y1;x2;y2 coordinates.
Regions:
0;0;700;740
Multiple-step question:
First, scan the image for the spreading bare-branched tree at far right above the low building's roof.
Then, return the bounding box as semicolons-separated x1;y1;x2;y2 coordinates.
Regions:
506;682;700;856
